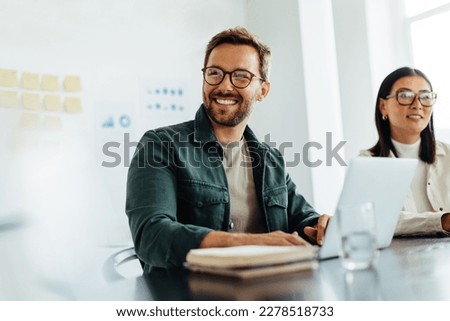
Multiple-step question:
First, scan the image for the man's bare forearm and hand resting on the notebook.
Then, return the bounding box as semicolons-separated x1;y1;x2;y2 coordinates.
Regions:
199;231;309;248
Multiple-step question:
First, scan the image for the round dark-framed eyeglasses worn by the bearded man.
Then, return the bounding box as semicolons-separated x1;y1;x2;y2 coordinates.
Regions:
202;67;265;89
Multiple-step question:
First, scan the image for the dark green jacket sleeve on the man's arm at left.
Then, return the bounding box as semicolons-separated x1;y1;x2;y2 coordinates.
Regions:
126;131;211;268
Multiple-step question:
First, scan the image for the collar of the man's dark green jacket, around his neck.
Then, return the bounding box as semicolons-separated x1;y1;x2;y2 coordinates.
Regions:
194;104;267;149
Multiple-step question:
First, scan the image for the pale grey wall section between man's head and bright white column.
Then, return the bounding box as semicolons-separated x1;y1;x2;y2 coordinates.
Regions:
247;0;313;202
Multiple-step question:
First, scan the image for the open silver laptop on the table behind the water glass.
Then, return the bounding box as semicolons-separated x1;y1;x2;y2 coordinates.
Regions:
319;157;418;259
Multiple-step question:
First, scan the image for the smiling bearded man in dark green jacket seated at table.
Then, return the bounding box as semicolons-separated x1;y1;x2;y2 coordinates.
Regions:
126;28;329;272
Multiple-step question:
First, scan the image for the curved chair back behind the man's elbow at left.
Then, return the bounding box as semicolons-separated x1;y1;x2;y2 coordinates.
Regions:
102;247;143;282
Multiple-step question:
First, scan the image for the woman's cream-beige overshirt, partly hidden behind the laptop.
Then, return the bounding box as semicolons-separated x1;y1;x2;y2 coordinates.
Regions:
360;141;450;235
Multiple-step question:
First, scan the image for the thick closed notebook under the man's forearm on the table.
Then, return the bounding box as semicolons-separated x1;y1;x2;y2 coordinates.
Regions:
185;245;317;279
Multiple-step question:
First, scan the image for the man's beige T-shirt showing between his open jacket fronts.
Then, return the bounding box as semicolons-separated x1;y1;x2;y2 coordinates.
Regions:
223;139;266;233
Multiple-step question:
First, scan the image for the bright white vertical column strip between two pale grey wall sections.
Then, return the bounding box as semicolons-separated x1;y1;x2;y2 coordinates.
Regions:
299;0;348;215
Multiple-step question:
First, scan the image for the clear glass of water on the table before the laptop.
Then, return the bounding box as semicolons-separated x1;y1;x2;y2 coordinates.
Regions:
337;202;378;270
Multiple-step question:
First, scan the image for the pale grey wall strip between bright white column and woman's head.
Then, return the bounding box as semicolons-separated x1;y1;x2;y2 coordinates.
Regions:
332;0;375;159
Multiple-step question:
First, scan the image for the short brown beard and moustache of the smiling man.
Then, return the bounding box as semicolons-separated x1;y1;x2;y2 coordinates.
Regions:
203;92;254;127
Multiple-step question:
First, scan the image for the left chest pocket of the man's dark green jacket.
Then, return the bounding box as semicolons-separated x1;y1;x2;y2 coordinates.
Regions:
177;180;229;229
